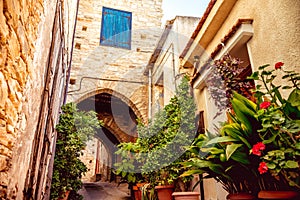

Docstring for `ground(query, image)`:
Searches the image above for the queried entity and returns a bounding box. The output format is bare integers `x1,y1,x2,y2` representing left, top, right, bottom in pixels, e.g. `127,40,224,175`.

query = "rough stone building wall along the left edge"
0,0,76,199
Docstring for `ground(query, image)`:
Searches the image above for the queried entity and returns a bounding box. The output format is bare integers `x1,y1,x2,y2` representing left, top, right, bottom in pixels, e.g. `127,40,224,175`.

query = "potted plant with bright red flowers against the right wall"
246,62,300,199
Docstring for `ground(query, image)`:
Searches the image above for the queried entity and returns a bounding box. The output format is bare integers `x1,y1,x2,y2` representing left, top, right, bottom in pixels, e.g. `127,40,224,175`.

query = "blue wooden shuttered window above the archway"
100,7,132,49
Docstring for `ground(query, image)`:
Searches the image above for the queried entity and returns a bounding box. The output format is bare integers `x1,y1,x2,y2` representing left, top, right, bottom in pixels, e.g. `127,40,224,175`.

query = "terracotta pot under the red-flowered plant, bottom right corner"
258,190,300,200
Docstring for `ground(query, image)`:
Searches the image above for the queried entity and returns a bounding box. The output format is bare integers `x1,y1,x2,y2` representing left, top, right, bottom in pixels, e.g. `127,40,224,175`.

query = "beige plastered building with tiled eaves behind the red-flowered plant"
180,0,300,199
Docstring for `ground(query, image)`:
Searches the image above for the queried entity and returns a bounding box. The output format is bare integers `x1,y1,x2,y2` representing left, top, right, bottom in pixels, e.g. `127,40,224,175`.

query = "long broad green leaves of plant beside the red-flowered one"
182,92,260,193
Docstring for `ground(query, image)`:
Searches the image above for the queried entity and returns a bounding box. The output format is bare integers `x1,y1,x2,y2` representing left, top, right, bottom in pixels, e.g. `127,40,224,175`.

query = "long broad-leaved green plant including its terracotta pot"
182,96,259,199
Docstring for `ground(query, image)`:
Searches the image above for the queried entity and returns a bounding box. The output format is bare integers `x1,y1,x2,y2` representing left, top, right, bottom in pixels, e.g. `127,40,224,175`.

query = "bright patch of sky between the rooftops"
162,0,210,24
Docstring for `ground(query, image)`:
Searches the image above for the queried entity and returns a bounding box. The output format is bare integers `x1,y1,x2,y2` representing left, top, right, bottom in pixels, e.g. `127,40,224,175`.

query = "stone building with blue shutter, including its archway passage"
68,0,162,181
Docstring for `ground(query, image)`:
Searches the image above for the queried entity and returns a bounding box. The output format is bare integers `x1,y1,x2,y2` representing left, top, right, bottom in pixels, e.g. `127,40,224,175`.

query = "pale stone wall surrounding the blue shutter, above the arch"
68,0,162,120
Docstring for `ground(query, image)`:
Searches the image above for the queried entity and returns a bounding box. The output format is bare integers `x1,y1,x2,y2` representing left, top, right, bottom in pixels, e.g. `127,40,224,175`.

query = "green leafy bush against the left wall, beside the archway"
50,103,100,199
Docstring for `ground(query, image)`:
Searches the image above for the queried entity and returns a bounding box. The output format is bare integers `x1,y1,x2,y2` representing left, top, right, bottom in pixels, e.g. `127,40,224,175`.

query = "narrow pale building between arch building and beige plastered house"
144,16,199,118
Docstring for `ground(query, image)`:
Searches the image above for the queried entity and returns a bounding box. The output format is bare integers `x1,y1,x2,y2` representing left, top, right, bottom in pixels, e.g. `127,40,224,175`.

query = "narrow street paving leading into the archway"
79,182,130,200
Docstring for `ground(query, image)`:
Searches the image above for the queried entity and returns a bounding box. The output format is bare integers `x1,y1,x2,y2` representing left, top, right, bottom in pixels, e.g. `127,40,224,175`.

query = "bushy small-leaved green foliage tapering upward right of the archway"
116,77,196,191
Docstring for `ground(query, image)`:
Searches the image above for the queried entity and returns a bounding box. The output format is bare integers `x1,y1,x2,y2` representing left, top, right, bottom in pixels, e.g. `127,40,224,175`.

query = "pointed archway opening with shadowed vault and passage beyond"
77,91,137,181
